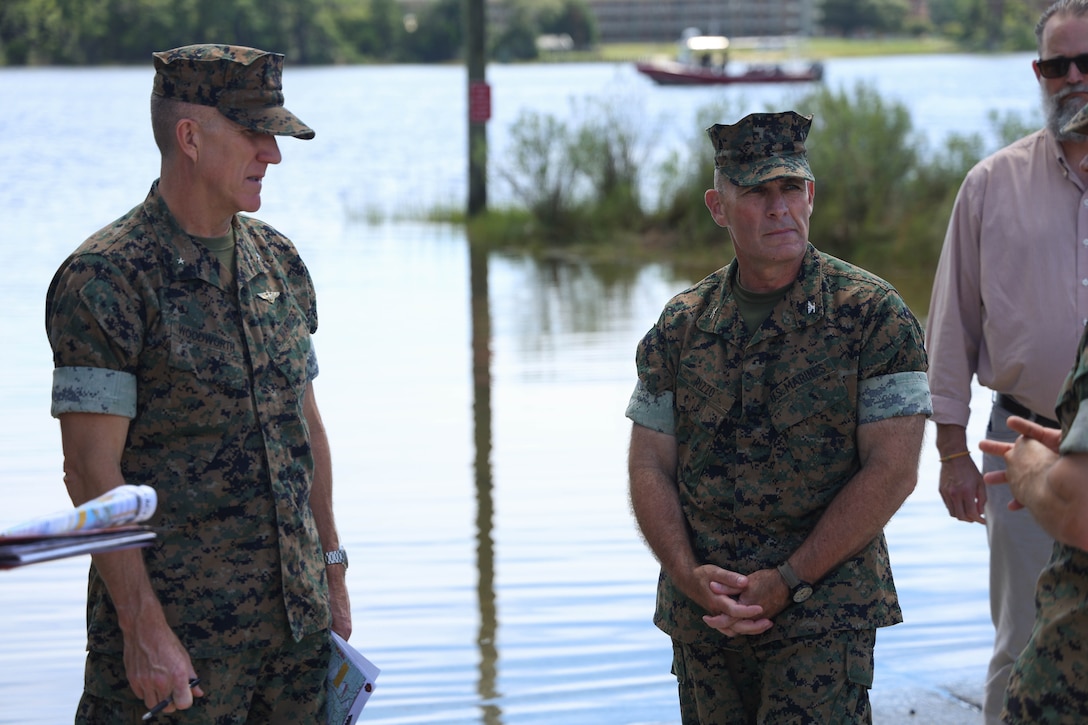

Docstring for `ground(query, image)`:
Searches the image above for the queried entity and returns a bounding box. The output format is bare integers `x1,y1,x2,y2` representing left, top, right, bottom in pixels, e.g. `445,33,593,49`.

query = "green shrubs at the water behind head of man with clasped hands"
486,84,1037,279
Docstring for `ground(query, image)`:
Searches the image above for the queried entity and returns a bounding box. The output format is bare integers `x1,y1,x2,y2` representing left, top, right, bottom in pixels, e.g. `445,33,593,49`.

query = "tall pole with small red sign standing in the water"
465,0,491,217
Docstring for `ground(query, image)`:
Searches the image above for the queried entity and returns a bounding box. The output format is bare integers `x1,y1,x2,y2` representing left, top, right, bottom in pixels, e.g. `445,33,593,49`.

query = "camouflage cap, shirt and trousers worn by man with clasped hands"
627,108,930,725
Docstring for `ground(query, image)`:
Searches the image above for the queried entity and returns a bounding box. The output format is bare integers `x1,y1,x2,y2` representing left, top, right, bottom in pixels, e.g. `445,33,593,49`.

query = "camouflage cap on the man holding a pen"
151,45,314,138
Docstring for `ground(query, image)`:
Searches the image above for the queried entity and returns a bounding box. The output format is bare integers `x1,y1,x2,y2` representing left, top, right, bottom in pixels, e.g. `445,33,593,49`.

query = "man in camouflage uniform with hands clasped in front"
627,111,930,725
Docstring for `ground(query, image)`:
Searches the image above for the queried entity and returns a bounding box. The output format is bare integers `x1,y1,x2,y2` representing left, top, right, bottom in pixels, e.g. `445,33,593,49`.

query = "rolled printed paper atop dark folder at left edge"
0,484,158,569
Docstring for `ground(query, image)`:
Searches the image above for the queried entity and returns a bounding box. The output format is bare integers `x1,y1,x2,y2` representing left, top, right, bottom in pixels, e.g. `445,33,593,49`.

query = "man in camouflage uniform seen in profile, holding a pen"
46,45,351,725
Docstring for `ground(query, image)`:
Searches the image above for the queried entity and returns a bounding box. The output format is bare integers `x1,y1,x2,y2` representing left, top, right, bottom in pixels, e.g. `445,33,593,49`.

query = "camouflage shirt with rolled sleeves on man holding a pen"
46,180,329,658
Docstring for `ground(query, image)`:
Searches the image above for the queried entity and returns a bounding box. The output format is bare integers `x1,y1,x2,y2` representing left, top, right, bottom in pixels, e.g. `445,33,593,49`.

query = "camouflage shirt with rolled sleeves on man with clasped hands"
628,239,930,714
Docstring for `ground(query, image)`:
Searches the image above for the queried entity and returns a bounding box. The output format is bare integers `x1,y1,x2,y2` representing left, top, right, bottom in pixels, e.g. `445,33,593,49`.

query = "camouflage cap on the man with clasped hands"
706,111,816,186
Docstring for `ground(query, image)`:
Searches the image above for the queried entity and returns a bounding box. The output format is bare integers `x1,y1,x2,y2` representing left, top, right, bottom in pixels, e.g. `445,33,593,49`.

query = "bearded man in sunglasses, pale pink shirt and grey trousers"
926,0,1088,725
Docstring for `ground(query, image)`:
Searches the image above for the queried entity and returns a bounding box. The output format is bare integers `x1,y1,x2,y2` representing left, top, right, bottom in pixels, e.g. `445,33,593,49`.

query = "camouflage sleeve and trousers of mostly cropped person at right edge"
1004,322,1088,725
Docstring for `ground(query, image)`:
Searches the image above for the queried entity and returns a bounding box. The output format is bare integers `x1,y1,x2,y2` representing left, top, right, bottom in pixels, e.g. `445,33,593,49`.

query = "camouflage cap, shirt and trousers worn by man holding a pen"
46,46,343,723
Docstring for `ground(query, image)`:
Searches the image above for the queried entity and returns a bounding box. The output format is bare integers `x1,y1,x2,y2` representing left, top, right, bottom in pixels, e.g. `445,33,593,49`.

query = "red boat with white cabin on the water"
635,30,824,86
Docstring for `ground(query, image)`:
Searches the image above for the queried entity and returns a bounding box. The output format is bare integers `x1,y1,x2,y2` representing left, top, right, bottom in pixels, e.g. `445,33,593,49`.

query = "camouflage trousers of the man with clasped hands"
672,629,876,725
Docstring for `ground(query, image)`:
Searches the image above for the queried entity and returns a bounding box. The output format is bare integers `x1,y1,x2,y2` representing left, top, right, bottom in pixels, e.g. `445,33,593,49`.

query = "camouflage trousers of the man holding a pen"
75,631,331,725
